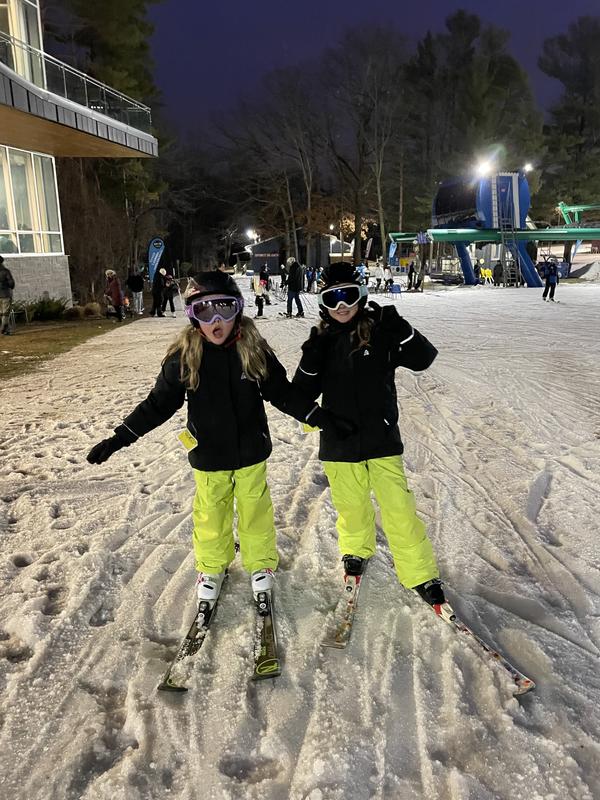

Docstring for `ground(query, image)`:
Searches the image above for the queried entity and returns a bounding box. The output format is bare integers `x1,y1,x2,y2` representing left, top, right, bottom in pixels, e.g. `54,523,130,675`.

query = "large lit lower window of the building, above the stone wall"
0,146,64,255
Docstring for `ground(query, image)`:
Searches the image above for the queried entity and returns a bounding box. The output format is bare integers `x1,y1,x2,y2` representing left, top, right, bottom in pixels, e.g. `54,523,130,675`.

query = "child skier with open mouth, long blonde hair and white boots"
87,270,351,602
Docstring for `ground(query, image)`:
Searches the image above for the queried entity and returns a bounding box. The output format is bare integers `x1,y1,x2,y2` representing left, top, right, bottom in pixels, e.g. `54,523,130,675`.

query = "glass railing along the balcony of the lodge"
0,31,152,133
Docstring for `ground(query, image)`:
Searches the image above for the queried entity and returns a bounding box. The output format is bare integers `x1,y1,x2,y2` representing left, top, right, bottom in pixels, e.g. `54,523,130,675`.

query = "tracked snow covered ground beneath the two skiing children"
0,283,600,800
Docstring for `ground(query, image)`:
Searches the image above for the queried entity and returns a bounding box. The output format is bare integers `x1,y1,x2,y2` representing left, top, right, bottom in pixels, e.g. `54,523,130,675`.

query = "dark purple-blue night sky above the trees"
151,0,600,132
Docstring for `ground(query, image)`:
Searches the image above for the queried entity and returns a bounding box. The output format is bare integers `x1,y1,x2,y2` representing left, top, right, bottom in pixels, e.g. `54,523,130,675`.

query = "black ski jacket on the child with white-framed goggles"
293,304,437,462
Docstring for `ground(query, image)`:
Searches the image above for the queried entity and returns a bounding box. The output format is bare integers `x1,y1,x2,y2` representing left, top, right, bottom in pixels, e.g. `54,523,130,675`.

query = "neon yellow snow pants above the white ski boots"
193,461,279,573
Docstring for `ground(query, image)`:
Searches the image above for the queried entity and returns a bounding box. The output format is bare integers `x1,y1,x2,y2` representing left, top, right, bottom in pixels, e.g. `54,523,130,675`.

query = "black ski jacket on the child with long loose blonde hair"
118,342,314,472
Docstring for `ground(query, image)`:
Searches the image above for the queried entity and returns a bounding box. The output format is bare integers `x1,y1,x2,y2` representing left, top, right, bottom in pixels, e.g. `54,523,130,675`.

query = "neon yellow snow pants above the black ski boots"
323,456,439,589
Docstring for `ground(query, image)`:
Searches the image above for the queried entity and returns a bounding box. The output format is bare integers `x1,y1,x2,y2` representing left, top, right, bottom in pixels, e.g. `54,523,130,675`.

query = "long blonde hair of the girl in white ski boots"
163,316,273,390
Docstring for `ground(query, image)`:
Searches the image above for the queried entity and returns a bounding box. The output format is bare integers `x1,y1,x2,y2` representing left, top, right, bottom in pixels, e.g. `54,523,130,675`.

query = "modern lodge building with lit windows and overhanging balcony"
0,0,158,305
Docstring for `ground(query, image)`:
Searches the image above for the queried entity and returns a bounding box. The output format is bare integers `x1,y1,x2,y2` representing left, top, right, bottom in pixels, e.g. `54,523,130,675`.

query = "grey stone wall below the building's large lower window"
4,254,73,306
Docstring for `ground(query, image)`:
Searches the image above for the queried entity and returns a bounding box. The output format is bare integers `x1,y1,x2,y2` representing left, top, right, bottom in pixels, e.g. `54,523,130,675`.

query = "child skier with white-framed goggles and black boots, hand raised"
293,263,445,606
